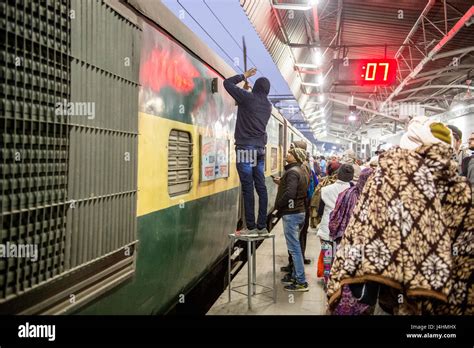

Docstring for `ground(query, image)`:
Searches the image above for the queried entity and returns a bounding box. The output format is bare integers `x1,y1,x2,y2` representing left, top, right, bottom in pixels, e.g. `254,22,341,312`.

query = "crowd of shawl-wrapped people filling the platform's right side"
310,117,474,315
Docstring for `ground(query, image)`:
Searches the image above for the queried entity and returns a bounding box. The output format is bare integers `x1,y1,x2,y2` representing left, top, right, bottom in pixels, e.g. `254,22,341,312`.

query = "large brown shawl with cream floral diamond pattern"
328,144,474,314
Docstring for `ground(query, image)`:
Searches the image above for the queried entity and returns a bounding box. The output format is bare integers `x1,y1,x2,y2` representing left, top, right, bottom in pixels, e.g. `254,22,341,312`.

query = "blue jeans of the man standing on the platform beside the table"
282,213,306,284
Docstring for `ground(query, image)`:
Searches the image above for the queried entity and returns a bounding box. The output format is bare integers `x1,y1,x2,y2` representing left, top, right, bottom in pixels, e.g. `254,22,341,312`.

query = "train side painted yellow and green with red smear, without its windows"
81,19,281,314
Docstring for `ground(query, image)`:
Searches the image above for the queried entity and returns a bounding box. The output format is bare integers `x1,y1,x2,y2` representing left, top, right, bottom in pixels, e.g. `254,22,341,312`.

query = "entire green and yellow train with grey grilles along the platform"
0,0,311,314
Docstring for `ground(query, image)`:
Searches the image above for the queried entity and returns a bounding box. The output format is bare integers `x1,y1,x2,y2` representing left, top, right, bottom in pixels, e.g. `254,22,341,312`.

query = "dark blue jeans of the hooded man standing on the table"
235,145,268,229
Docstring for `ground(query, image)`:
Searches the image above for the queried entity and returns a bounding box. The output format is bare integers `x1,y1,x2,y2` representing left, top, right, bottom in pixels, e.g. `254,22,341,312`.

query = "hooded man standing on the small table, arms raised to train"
224,69,272,235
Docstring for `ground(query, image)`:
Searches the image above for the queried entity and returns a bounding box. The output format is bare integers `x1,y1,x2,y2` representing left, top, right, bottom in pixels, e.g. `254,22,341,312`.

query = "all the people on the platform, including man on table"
224,69,474,315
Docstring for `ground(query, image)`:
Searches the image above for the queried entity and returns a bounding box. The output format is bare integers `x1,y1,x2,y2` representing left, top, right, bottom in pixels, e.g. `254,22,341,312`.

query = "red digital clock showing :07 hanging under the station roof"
334,59,397,86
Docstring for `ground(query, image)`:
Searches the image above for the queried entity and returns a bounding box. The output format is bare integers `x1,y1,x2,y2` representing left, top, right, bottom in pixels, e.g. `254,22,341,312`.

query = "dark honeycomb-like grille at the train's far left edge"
0,0,70,304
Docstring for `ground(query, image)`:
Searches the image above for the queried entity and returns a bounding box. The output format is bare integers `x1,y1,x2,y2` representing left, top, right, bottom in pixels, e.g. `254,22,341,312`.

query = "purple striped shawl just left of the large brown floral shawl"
329,168,374,242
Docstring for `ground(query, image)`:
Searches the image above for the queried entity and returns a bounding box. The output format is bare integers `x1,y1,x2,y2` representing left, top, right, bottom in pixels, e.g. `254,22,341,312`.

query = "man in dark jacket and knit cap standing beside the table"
275,147,309,291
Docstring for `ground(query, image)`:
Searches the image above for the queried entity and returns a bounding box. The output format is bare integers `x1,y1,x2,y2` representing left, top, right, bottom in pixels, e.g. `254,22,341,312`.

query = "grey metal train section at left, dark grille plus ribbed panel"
0,0,140,315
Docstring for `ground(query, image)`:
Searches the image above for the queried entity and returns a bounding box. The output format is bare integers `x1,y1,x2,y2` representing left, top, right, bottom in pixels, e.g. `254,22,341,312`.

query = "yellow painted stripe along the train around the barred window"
137,112,282,216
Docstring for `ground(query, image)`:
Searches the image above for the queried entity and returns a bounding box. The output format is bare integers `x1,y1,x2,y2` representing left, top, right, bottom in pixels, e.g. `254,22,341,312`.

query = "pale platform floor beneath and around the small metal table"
207,220,327,315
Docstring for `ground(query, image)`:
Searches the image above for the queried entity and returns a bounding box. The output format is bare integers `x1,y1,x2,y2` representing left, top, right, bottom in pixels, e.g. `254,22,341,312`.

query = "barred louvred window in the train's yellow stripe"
168,129,193,197
